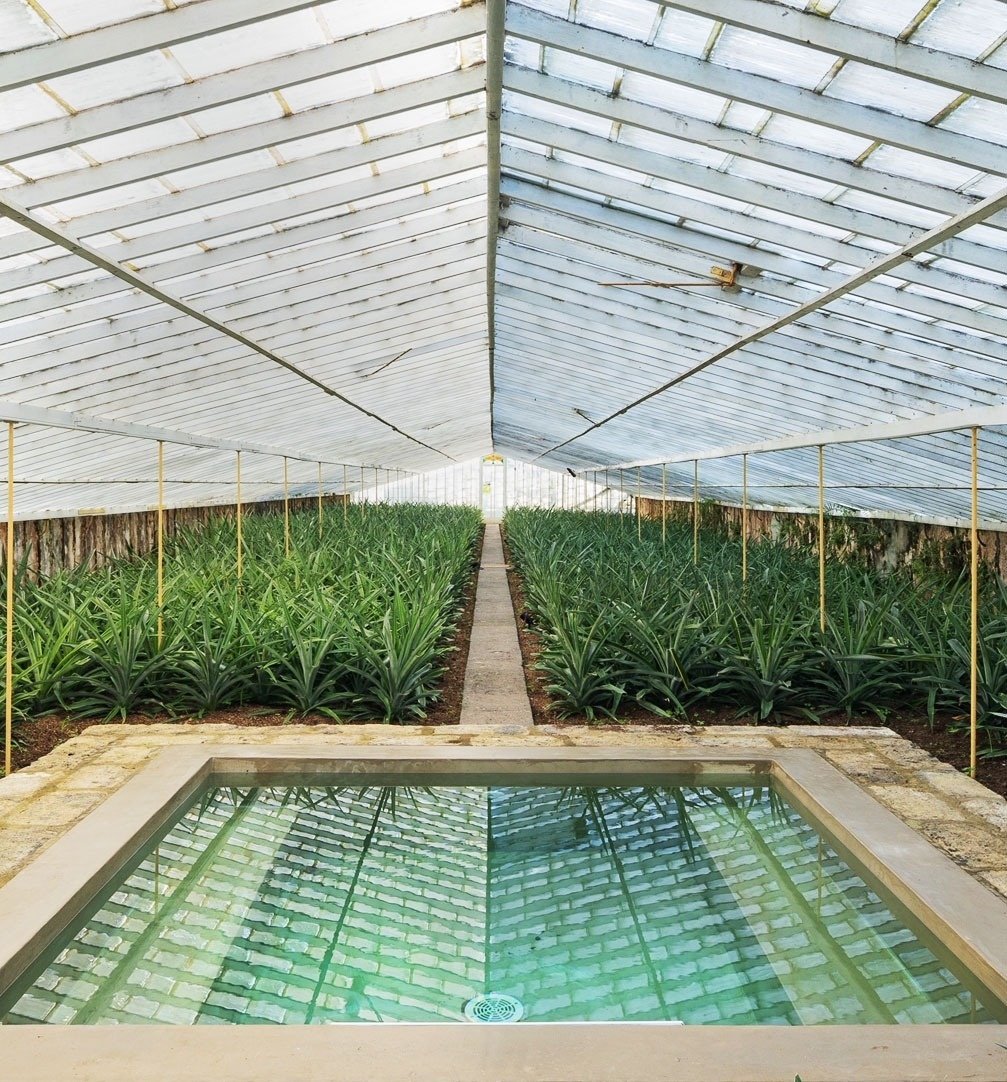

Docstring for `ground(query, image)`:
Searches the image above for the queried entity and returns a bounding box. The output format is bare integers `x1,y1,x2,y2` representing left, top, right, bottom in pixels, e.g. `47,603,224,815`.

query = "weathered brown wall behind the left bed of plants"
0,496,343,577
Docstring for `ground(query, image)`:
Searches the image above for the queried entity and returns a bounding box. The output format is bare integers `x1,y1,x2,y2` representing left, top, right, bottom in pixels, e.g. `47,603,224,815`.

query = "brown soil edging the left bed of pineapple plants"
0,525,482,775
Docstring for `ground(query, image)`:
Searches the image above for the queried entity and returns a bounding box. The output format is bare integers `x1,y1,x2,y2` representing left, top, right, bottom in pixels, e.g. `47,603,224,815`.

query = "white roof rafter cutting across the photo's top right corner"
650,0,1007,103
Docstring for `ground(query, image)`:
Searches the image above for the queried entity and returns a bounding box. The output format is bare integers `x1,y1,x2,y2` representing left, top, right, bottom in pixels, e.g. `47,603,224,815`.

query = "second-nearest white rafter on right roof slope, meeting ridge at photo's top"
507,2,1007,175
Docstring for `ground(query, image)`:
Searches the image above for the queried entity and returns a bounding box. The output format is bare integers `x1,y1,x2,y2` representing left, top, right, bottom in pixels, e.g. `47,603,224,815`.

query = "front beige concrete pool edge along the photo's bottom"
3,1022,1007,1082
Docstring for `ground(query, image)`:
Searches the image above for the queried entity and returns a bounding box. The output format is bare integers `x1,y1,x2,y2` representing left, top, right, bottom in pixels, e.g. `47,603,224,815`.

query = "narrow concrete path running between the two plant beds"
461,523,532,729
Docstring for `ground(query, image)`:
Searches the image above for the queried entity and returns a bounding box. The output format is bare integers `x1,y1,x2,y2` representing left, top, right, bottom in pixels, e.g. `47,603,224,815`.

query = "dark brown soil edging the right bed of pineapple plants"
504,536,1007,797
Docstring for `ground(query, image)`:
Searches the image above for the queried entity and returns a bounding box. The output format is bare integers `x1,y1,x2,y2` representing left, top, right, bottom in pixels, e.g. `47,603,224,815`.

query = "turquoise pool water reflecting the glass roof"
0,777,1007,1026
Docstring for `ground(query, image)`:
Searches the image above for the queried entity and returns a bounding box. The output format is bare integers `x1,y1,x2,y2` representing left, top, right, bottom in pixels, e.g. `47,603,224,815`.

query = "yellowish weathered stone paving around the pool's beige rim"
0,717,1007,897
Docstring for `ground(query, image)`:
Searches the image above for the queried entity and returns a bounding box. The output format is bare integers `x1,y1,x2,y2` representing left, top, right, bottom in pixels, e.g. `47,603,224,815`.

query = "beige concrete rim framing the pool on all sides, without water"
0,727,1007,1082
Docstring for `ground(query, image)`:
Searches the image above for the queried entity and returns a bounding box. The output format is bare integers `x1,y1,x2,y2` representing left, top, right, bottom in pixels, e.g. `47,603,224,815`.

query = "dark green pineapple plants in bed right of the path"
506,510,1007,755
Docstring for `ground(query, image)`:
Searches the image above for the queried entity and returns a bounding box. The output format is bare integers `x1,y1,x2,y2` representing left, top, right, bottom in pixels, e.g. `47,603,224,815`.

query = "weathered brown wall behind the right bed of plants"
640,498,1007,580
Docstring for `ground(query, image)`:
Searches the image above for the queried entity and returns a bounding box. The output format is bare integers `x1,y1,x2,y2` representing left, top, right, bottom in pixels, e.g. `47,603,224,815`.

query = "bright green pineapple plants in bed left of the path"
0,505,479,722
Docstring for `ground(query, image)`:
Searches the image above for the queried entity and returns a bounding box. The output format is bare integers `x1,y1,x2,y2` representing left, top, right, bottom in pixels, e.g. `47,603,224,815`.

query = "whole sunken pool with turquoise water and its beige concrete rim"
0,744,1007,1082
